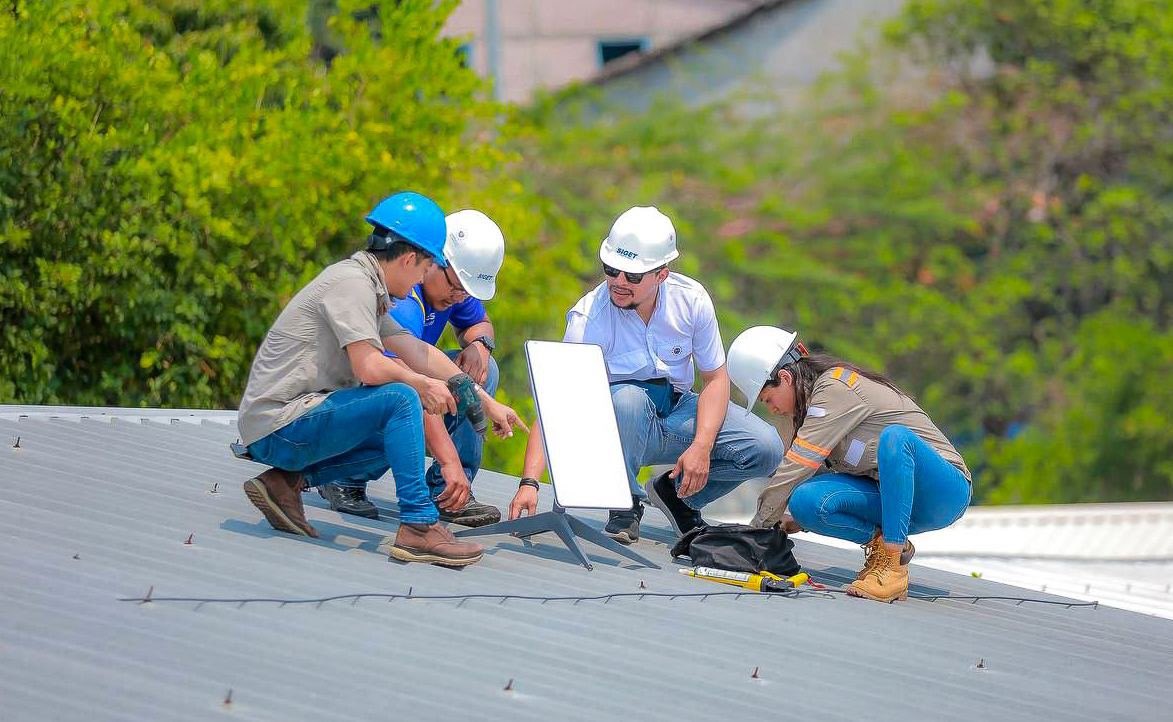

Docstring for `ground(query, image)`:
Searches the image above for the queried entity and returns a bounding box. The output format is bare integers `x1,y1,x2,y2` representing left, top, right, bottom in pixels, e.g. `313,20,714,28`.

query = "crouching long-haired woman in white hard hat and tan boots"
728,326,972,601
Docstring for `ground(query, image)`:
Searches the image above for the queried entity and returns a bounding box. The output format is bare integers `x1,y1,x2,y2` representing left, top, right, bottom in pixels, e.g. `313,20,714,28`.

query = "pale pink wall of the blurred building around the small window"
445,0,760,102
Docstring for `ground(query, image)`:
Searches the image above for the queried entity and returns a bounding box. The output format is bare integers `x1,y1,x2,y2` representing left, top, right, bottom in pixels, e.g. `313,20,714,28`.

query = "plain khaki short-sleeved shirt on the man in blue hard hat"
238,251,407,445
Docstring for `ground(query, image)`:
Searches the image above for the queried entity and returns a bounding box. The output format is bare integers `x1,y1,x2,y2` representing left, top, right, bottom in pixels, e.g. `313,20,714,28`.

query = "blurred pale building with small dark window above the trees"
445,0,903,102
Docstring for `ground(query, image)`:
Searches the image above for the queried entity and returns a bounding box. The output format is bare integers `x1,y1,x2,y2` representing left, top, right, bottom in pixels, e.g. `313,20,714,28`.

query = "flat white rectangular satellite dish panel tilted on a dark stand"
526,341,631,509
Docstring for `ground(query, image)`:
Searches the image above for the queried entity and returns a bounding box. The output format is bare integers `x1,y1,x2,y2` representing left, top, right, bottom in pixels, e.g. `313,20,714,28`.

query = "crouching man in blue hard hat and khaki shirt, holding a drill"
239,192,526,566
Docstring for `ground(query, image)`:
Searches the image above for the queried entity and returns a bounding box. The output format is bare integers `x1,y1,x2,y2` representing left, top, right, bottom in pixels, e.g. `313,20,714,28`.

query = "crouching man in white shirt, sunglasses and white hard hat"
509,206,784,544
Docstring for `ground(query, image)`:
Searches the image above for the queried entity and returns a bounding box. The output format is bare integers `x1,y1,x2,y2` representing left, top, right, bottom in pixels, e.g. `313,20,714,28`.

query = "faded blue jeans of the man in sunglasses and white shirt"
611,381,784,509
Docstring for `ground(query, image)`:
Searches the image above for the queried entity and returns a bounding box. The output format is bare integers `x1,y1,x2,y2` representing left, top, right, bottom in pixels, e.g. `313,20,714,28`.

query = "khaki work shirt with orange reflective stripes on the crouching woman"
751,367,972,526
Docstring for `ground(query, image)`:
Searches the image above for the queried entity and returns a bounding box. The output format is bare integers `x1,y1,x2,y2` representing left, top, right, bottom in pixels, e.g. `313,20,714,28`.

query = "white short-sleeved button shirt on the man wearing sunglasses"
562,273,725,391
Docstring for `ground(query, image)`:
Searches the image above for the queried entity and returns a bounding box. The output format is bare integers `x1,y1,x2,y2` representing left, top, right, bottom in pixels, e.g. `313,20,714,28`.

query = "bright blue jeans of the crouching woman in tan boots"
789,424,972,544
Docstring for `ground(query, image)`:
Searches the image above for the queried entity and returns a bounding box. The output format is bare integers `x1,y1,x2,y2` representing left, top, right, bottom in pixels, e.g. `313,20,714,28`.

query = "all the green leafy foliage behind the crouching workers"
0,0,1173,502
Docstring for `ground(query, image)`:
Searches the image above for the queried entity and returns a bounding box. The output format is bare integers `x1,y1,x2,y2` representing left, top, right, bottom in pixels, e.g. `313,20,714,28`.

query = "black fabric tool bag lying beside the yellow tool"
672,524,802,578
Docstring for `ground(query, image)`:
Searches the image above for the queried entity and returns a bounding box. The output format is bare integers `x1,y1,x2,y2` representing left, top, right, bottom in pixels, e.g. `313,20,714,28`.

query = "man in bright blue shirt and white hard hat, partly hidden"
318,210,504,526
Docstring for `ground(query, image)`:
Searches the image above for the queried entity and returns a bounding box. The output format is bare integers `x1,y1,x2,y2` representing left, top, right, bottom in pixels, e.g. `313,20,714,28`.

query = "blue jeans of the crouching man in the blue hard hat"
249,383,440,524
